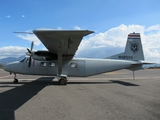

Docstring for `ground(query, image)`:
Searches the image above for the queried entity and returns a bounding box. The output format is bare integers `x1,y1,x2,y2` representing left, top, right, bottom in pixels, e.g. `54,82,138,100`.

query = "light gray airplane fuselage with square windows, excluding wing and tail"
4,57,142,77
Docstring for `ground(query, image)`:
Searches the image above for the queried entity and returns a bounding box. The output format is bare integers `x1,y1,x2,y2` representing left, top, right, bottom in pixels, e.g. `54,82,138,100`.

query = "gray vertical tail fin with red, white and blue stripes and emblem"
107,33,144,61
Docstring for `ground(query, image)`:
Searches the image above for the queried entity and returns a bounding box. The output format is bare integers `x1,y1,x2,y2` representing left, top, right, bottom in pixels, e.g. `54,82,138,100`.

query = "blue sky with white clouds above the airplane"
0,0,160,63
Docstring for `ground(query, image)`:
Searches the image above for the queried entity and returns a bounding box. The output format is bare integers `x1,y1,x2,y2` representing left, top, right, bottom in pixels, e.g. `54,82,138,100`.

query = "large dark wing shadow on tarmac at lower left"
0,77,54,120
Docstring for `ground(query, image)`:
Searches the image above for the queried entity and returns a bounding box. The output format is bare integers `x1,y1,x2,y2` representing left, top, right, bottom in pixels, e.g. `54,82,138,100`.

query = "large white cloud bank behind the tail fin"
75,24,160,62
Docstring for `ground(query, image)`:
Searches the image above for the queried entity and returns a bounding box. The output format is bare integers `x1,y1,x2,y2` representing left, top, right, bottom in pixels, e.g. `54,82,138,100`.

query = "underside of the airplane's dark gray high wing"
33,30,93,56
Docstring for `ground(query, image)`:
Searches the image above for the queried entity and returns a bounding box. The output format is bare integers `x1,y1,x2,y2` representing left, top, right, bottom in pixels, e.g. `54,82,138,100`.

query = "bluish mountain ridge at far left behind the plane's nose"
0,56,25,65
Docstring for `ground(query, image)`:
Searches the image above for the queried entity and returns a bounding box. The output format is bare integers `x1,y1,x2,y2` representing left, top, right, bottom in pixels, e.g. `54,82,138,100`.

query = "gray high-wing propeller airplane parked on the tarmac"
4,29,149,85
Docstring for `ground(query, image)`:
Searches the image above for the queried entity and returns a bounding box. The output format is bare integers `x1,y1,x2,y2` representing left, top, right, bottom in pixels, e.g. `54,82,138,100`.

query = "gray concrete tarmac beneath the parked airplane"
0,69,160,120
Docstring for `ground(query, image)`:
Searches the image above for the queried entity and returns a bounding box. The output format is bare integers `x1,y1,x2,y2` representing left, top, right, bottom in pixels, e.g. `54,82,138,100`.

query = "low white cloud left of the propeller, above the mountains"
0,46,27,59
